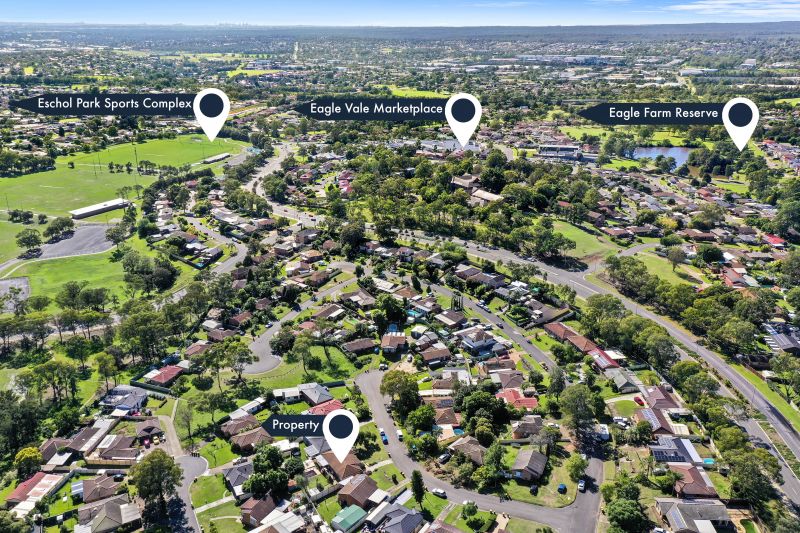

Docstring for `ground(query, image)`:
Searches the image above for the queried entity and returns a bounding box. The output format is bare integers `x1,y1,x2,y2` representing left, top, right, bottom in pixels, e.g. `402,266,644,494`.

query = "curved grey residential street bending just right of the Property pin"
356,370,603,533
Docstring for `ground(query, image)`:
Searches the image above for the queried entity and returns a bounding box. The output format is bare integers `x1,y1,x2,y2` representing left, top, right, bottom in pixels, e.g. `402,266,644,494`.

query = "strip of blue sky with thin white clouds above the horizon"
0,0,800,26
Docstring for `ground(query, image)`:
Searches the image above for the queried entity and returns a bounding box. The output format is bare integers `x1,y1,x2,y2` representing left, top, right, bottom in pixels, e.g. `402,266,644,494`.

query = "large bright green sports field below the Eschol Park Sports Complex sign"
0,135,247,215
